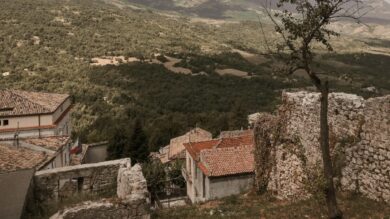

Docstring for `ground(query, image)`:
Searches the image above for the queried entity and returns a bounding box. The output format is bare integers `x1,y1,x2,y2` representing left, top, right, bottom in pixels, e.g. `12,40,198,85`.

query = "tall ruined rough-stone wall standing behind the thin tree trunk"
257,92,390,202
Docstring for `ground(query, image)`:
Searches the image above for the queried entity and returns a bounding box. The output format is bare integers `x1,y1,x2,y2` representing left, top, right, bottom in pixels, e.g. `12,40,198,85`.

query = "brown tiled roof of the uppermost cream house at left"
0,90,69,116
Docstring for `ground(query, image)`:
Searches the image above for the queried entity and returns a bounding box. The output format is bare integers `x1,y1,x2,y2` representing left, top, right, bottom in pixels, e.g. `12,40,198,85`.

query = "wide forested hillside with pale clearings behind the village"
0,0,390,150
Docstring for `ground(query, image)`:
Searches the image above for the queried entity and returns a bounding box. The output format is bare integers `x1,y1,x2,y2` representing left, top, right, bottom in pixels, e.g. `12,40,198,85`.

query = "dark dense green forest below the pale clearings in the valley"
80,63,292,150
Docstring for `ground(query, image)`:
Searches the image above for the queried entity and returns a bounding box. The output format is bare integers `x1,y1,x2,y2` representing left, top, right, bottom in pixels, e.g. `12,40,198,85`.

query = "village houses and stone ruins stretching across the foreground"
0,90,390,219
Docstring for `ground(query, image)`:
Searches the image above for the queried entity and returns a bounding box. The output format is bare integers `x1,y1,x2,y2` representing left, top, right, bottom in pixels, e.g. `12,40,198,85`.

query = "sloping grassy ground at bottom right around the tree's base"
152,194,390,219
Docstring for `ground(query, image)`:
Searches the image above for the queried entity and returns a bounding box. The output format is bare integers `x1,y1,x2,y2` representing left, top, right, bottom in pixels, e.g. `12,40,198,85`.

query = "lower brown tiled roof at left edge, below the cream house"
0,145,48,173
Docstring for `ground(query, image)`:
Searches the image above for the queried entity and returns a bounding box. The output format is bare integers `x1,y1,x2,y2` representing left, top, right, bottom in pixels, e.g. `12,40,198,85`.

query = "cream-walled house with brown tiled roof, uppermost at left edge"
0,90,72,139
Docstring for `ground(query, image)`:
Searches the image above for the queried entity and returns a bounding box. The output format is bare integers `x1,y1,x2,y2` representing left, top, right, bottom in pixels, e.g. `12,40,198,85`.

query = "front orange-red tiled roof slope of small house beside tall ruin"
198,146,255,176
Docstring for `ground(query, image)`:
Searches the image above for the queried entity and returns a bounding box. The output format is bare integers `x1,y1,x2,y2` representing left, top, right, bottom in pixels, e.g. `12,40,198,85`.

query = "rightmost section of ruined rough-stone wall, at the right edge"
341,96,390,202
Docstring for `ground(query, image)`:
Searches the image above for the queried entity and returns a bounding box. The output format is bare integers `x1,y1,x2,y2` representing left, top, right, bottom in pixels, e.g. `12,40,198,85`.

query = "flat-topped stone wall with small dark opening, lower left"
34,159,130,203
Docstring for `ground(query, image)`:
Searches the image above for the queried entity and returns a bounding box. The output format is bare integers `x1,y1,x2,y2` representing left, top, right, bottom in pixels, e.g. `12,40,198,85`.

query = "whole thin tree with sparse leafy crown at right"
261,0,368,218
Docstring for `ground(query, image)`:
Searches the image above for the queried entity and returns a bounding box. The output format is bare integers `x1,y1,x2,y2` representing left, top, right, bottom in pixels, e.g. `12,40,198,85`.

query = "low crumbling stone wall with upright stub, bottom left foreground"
51,164,150,219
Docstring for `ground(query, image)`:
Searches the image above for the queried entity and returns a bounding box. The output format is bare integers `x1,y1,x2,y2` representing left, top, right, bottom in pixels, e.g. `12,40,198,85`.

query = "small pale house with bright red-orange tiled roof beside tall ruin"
182,134,254,203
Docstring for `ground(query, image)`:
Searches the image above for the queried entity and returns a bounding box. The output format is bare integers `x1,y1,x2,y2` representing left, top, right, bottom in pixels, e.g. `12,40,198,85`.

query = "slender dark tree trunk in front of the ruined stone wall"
320,81,343,219
